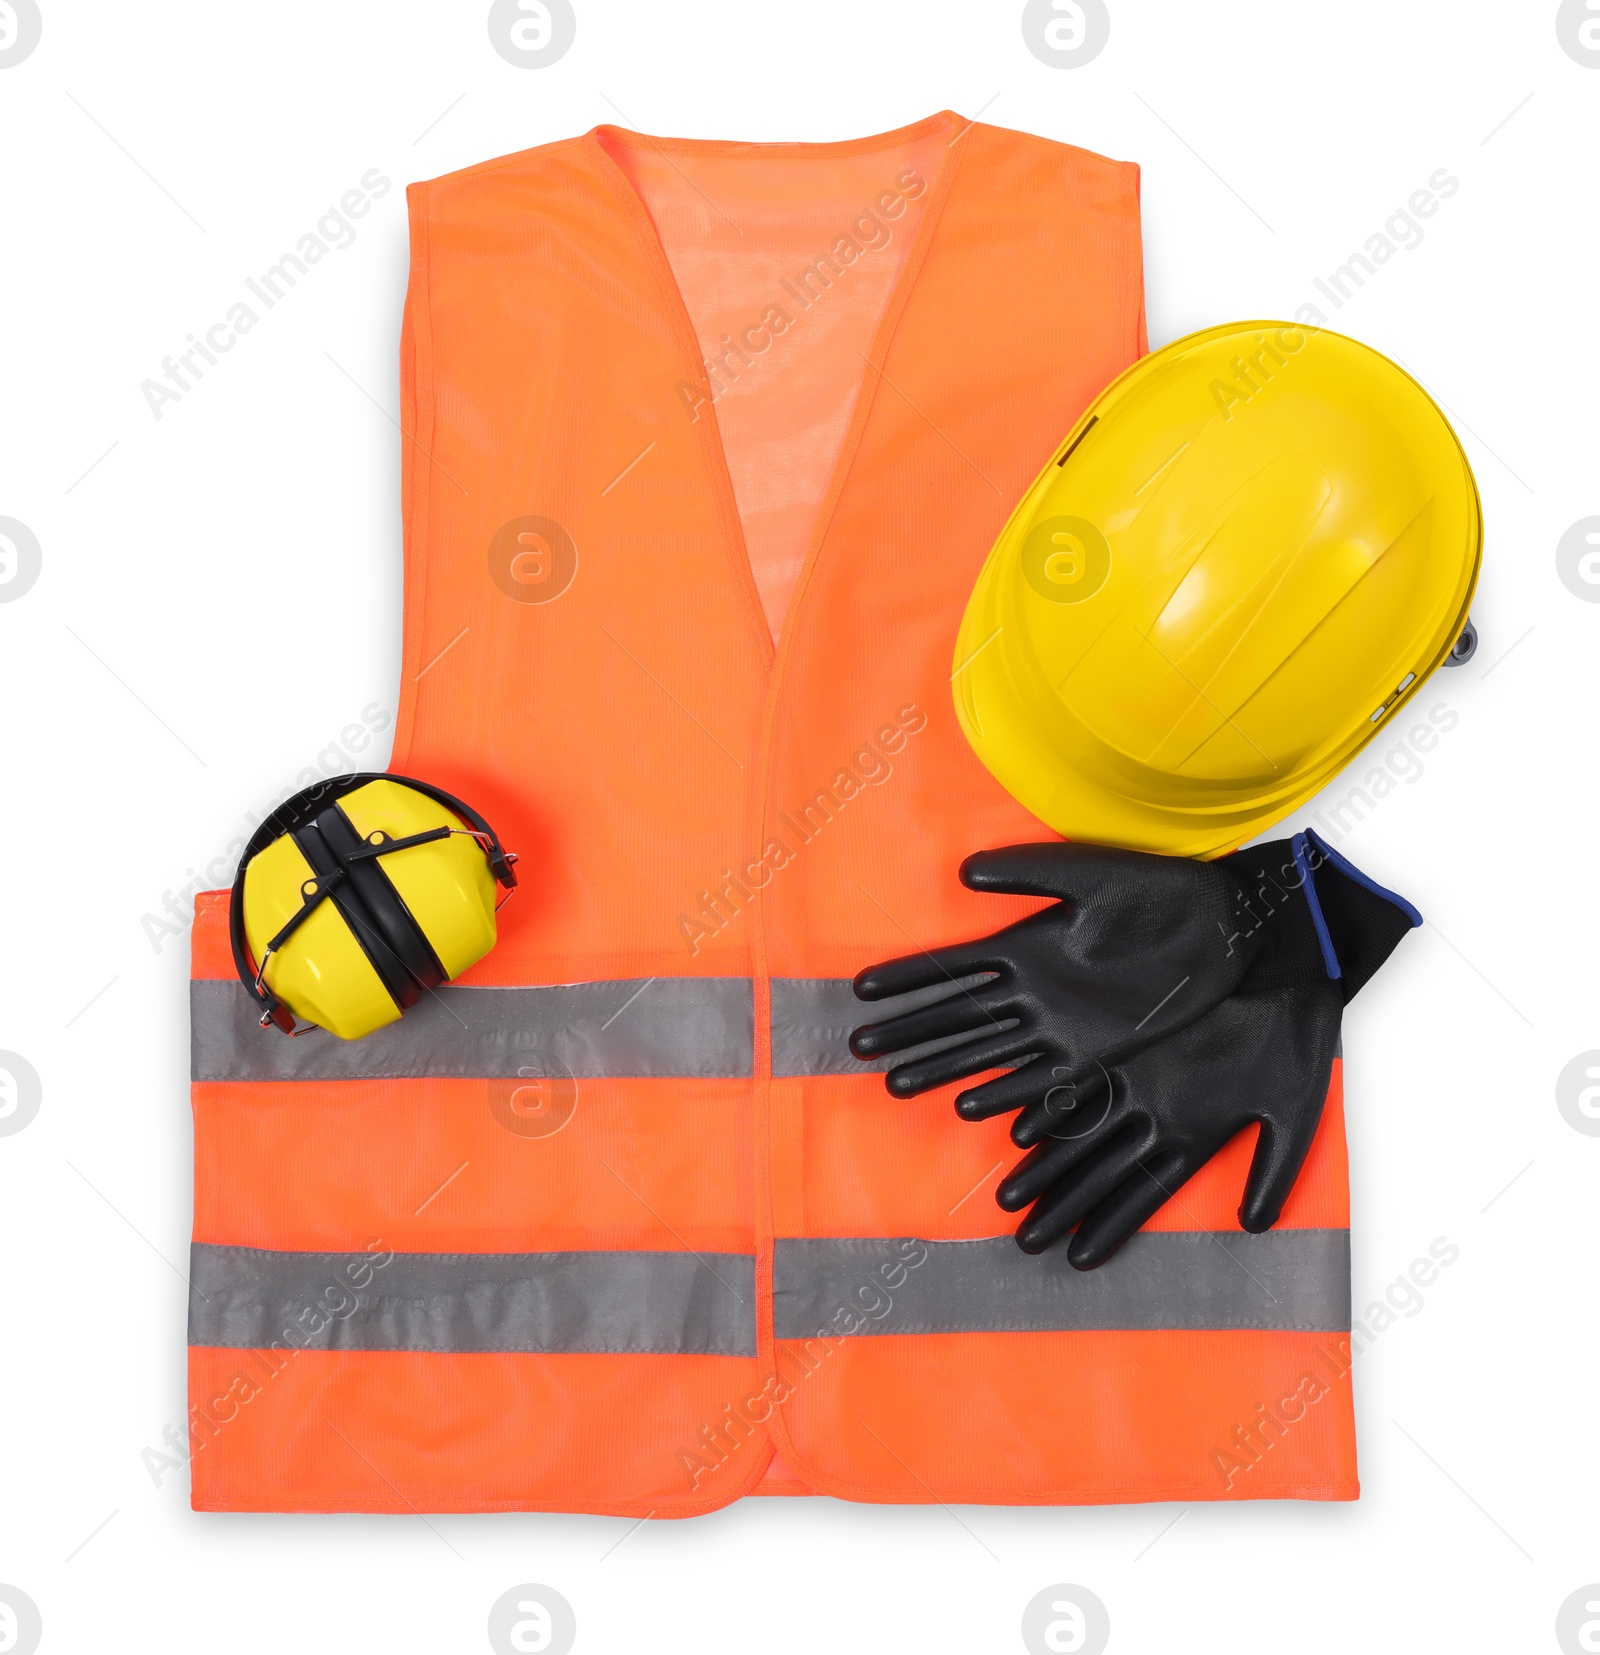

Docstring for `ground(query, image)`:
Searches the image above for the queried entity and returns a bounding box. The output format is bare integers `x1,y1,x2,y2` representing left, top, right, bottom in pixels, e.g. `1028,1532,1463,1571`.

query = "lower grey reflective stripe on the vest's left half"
189,1243,756,1355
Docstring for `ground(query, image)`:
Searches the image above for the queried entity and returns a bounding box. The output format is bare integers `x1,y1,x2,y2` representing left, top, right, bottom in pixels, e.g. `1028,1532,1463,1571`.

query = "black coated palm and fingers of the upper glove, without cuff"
850,841,1292,1120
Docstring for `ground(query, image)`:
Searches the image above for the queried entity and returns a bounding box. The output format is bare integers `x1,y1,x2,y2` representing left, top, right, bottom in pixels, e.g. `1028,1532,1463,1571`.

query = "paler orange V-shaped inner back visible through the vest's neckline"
599,118,955,639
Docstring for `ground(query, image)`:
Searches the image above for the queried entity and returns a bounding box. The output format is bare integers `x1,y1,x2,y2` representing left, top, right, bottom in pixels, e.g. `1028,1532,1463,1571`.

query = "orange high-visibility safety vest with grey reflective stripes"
190,114,1357,1518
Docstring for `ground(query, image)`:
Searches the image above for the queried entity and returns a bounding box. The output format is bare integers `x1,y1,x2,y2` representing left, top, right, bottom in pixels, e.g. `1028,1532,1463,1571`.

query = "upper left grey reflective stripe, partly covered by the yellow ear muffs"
189,976,754,1081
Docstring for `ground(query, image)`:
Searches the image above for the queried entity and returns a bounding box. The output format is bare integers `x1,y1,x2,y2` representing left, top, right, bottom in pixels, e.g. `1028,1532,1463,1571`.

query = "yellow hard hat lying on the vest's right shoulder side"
951,321,1483,857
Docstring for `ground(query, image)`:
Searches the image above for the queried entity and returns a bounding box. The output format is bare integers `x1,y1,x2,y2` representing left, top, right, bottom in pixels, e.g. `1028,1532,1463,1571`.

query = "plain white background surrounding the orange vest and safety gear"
0,0,1600,1652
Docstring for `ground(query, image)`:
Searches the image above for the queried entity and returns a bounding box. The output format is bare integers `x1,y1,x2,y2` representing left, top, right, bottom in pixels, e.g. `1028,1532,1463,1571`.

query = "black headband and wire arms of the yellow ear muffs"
228,771,516,1034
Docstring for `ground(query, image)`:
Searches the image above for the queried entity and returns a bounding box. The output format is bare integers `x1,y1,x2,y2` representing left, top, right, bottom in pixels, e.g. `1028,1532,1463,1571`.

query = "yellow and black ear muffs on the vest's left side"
228,773,516,1039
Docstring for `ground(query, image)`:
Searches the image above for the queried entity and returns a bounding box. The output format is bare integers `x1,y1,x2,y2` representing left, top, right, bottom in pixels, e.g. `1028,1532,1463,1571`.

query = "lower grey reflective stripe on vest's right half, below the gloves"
773,1230,1350,1339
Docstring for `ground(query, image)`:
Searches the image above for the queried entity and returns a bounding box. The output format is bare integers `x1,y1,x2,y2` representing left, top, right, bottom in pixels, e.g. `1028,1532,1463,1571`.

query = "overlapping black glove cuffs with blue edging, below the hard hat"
1224,829,1423,1005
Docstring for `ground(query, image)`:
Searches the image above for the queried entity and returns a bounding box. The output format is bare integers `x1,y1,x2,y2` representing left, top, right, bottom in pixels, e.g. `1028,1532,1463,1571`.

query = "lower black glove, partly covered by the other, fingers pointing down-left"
852,832,1421,1269
